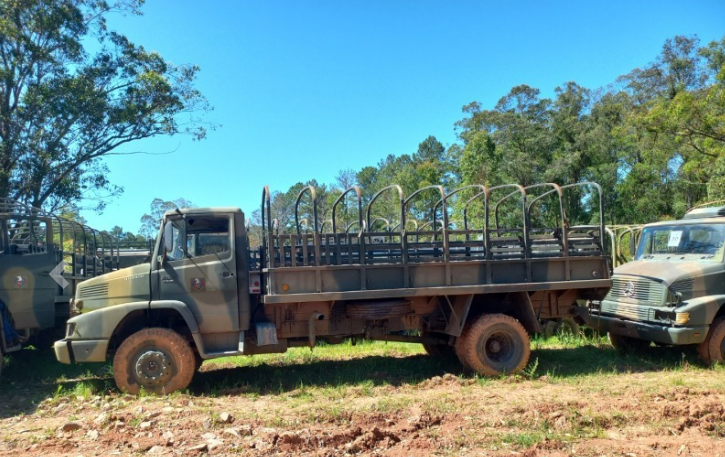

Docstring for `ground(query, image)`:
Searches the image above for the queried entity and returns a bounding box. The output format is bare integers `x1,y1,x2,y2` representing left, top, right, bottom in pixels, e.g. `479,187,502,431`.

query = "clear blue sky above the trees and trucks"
82,0,725,232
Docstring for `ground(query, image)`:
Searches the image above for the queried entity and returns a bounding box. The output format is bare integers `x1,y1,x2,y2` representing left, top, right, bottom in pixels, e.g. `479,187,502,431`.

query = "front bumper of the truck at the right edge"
586,314,710,345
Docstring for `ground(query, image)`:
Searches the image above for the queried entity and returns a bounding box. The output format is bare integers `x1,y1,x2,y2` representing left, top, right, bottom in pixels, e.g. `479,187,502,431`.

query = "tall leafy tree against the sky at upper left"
0,0,209,210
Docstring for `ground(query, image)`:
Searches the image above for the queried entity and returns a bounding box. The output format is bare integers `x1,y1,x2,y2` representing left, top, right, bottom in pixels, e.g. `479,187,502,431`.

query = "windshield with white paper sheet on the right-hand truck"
637,224,725,262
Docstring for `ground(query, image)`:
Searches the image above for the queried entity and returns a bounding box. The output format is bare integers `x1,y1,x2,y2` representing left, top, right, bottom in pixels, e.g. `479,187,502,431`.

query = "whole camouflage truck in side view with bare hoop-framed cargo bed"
55,183,611,393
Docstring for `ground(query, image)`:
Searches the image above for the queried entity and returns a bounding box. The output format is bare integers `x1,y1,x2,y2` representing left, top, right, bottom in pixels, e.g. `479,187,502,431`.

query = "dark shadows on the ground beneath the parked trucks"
0,343,701,417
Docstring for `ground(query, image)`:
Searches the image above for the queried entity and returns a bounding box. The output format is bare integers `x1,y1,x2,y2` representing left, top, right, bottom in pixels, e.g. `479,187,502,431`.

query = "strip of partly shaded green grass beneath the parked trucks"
0,330,725,415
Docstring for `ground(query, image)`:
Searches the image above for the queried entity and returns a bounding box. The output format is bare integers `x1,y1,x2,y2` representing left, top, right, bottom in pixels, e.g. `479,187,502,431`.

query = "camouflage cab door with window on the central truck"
157,214,239,333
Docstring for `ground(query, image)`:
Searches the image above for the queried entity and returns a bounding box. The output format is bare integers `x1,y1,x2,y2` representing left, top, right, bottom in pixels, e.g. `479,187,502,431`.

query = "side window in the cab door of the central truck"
186,216,232,259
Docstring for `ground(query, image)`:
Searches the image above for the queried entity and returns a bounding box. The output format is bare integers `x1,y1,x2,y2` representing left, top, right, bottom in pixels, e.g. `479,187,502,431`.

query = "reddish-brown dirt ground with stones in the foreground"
0,350,725,457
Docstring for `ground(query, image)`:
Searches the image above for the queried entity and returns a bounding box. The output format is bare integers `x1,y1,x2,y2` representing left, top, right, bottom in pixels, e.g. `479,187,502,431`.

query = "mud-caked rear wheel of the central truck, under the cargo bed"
461,314,531,376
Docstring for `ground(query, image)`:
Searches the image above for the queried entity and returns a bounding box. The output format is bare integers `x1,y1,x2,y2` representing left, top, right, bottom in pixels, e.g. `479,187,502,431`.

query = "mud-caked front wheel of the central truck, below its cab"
113,328,196,394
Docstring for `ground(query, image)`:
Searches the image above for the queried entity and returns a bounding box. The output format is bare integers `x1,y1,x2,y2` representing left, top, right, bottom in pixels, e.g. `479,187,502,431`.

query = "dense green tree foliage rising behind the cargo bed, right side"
255,36,725,233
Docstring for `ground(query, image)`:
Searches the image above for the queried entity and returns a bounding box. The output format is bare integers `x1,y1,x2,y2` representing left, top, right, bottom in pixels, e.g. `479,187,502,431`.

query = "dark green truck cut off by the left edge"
0,199,118,376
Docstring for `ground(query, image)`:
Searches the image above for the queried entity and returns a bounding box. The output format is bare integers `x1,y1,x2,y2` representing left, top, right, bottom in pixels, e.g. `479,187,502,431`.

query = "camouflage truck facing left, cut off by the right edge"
582,207,725,364
